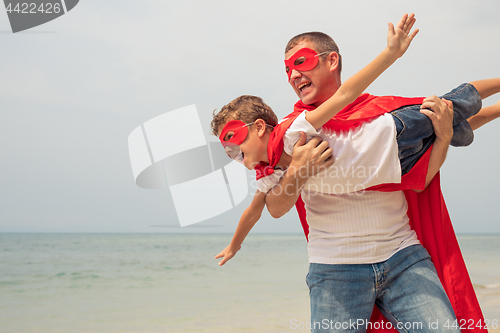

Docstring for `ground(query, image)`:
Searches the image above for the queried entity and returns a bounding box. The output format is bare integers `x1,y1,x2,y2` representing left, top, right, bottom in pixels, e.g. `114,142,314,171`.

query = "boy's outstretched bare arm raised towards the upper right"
306,14,418,128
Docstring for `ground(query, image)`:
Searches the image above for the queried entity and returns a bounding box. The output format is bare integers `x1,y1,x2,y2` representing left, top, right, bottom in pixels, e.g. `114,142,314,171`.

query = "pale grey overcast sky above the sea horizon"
0,0,500,233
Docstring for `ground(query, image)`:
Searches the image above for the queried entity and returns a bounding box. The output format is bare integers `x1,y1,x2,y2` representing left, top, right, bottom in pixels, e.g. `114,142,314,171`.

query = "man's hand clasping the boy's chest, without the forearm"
287,132,334,178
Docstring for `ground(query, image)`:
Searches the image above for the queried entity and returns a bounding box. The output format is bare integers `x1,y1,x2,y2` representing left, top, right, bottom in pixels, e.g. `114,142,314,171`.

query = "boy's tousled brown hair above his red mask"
210,95,278,136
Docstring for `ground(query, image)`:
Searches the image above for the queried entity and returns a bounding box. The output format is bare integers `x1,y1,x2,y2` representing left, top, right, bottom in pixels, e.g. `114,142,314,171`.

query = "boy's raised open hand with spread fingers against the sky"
387,13,418,58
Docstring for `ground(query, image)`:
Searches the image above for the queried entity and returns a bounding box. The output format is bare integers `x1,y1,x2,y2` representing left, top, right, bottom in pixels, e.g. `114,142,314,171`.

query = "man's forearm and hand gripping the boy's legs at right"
420,96,453,187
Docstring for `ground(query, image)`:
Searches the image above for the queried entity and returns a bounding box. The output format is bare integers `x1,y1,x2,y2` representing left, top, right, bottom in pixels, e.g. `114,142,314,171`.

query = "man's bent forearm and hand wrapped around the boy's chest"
266,132,334,218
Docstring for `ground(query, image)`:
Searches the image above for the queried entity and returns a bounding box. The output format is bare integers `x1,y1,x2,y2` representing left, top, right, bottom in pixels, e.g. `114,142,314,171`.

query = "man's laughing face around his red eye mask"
285,40,339,107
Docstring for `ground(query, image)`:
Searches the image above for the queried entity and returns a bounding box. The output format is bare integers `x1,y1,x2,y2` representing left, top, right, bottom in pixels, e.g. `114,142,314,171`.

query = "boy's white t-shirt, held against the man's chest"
257,111,401,194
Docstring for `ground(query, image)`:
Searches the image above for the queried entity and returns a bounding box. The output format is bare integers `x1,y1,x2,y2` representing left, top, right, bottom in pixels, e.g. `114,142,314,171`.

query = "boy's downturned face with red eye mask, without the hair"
218,119,269,170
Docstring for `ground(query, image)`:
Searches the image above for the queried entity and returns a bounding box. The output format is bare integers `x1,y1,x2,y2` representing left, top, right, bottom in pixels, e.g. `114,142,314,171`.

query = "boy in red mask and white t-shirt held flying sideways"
212,18,500,265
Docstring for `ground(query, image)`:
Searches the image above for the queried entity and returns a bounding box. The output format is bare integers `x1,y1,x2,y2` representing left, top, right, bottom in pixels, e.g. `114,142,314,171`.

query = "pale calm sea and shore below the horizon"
0,233,500,333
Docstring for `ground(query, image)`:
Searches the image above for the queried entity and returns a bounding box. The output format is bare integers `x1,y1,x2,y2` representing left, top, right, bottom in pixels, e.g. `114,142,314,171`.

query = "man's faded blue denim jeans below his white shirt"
306,245,460,333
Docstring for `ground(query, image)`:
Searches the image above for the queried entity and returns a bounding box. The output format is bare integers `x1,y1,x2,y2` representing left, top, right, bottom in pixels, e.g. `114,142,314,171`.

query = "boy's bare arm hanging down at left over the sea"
215,191,266,266
